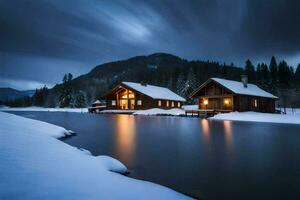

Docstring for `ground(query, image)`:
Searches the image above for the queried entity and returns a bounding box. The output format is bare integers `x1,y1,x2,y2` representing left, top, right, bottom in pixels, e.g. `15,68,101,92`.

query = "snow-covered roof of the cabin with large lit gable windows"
122,82,185,101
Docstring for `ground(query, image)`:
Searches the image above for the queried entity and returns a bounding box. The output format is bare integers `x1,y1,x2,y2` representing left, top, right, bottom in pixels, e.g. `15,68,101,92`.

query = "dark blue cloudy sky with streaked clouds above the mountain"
0,0,300,89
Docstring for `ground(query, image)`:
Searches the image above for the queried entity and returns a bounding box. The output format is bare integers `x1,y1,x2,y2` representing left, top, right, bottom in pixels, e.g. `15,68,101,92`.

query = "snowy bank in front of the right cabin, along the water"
210,112,300,124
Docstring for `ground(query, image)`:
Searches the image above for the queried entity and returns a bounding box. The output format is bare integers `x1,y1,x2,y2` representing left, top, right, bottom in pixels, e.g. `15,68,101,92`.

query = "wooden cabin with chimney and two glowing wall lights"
191,76,278,113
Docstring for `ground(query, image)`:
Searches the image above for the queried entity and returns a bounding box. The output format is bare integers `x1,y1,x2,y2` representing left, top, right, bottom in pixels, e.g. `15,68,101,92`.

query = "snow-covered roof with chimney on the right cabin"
211,78,278,98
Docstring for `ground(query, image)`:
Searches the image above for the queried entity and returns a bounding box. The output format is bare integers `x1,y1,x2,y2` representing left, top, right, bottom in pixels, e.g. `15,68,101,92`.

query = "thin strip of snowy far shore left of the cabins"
0,106,88,113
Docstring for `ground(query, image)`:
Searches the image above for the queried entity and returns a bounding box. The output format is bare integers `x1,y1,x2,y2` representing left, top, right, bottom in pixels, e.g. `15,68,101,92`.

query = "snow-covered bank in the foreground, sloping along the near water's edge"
0,112,188,200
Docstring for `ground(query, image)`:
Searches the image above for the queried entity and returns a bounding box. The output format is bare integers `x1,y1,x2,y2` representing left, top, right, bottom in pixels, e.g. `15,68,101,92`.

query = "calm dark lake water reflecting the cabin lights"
8,112,300,199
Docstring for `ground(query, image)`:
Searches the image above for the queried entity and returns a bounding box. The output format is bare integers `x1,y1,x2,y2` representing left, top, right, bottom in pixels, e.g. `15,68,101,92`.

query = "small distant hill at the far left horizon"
0,88,35,101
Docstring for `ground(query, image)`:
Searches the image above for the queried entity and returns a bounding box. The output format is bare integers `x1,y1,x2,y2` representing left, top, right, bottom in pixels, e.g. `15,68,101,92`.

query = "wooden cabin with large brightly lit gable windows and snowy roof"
102,82,185,110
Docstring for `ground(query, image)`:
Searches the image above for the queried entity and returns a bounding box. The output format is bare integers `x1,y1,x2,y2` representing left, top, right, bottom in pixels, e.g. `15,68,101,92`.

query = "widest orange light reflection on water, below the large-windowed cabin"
115,115,136,162
